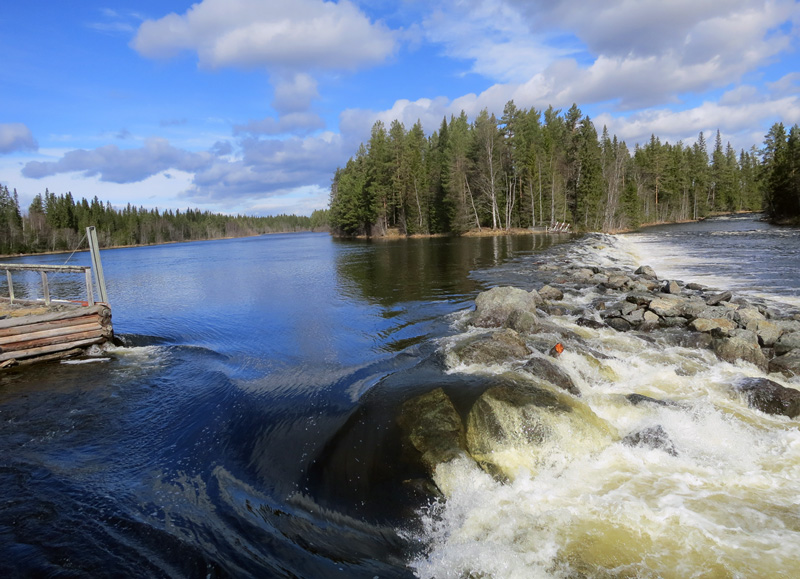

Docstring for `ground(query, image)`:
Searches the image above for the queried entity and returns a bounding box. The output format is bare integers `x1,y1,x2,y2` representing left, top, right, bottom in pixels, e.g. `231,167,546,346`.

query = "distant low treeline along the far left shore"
0,186,327,254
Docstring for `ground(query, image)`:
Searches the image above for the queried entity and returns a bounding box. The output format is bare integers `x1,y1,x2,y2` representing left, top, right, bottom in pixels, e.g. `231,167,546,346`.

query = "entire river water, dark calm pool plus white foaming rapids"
0,217,800,578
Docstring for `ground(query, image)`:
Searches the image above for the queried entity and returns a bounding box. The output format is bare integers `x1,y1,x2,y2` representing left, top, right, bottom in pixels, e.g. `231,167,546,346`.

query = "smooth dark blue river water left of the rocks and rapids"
0,234,564,578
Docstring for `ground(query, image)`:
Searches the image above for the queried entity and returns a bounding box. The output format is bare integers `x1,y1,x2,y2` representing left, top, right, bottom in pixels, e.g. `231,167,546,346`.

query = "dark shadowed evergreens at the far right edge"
762,123,800,222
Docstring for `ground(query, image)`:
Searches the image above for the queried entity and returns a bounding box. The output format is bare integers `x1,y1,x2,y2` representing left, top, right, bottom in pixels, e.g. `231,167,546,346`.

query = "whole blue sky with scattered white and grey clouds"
0,0,800,215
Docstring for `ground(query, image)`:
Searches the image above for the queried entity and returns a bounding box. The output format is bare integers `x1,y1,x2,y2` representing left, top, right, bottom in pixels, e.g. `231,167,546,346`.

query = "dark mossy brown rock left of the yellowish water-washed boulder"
397,388,467,473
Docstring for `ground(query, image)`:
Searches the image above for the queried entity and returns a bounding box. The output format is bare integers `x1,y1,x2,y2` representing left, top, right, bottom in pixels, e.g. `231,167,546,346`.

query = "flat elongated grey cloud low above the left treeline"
22,138,213,183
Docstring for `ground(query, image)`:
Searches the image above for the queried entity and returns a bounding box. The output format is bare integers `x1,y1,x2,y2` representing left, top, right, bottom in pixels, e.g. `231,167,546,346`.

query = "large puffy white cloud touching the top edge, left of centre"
132,0,396,70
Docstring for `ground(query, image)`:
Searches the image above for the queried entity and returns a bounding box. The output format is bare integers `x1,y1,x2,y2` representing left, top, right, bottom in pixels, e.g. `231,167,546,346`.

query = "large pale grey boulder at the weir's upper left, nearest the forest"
471,287,541,331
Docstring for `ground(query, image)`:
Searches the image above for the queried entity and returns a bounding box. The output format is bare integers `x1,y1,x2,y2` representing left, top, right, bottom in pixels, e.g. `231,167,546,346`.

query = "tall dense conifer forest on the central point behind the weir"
330,101,764,236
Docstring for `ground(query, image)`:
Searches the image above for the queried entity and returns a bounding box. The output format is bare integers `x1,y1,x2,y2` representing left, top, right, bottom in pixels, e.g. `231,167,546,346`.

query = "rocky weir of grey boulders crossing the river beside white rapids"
398,263,800,494
